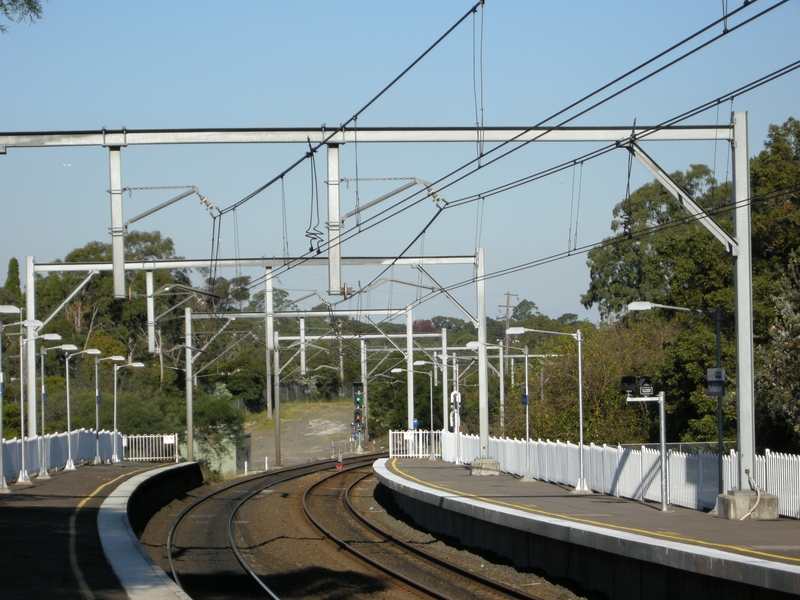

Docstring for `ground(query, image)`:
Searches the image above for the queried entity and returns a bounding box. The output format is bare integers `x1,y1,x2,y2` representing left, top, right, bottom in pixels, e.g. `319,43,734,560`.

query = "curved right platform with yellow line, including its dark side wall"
375,458,800,598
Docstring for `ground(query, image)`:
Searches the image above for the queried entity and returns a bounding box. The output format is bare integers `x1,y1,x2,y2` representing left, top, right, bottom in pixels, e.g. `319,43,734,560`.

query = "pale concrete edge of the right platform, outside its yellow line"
374,459,800,594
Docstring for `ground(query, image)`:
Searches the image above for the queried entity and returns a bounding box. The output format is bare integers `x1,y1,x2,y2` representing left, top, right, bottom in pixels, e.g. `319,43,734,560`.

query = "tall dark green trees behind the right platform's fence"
581,118,800,451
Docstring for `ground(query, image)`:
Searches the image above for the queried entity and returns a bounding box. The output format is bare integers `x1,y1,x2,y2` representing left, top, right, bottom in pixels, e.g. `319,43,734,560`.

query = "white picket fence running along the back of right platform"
389,431,800,519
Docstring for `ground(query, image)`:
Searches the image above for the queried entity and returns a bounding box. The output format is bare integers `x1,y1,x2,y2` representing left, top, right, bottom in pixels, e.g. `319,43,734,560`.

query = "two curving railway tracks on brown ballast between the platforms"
162,455,552,600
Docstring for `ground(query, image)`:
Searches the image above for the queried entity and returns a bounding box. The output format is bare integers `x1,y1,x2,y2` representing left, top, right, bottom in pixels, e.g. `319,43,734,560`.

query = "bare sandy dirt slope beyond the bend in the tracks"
245,402,368,470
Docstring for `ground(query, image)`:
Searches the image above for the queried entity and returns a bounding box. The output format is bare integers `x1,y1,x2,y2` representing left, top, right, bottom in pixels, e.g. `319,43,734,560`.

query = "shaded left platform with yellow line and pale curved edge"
0,462,191,599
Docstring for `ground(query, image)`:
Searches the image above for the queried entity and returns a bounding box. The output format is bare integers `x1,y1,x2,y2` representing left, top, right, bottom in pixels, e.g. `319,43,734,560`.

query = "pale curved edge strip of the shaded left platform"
97,463,195,600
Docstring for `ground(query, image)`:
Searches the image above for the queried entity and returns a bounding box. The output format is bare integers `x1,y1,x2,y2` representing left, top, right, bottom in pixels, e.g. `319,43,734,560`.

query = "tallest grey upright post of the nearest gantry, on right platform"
733,112,756,489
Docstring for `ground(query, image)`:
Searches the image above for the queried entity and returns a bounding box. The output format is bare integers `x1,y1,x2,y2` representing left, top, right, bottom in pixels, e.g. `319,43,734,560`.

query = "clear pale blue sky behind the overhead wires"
0,0,800,322
